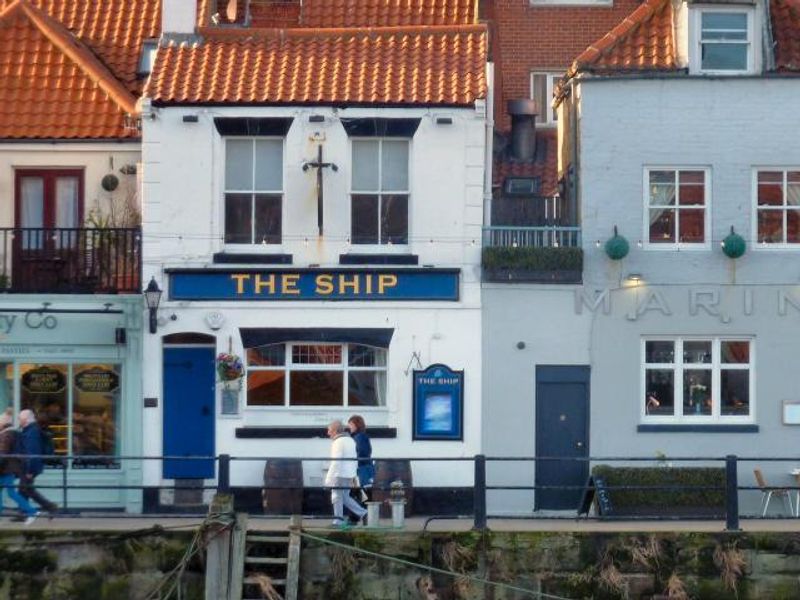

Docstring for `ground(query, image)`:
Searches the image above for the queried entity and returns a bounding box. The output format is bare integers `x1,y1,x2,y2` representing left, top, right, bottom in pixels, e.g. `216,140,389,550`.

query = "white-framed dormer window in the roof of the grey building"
693,8,754,74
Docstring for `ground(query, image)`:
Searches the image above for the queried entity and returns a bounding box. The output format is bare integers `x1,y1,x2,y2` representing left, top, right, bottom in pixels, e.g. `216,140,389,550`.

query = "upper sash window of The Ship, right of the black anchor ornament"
350,138,409,244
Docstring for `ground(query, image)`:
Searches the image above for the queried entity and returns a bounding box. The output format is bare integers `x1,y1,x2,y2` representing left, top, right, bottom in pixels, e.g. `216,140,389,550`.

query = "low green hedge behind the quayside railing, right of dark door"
592,465,725,514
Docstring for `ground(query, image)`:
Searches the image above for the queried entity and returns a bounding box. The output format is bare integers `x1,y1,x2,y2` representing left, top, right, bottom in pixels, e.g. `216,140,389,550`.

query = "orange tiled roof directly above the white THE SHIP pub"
145,25,487,105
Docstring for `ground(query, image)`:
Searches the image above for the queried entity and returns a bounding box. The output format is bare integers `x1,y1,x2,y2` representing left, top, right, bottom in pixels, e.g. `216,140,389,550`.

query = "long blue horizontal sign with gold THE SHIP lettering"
169,268,459,302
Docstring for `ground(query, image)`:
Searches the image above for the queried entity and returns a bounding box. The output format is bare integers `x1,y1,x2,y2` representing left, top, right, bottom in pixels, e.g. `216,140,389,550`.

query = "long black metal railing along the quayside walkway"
6,454,800,531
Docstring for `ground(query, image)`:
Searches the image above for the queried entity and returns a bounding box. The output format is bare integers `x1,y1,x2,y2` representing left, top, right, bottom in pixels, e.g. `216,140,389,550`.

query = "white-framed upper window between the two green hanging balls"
645,168,709,247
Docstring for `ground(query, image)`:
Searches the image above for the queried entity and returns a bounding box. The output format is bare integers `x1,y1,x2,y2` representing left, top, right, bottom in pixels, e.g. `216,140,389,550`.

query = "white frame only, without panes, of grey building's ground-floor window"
638,335,756,425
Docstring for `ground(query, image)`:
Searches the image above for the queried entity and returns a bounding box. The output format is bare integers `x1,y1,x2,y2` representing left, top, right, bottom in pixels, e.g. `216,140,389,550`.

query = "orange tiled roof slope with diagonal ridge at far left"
0,0,147,139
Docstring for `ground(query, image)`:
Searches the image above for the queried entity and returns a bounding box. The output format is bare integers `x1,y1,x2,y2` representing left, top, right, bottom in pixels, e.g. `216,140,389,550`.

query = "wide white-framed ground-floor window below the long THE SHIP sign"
247,342,387,408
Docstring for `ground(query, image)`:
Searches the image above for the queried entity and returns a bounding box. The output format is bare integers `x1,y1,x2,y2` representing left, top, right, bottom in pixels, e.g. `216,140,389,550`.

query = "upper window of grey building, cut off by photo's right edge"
756,169,800,244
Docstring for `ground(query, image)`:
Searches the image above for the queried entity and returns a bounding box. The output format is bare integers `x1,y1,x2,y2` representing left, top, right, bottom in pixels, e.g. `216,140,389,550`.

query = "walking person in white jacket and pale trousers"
325,421,367,527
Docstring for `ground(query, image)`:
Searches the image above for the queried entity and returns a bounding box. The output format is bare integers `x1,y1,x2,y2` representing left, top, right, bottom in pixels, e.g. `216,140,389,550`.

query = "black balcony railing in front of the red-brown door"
0,227,142,294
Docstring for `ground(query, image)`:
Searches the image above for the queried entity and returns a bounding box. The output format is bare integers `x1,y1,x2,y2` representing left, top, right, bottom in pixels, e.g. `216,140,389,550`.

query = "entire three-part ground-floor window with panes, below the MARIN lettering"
641,336,755,423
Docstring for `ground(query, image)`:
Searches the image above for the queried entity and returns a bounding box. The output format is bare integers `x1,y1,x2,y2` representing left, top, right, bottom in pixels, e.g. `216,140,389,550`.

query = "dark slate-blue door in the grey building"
535,366,589,510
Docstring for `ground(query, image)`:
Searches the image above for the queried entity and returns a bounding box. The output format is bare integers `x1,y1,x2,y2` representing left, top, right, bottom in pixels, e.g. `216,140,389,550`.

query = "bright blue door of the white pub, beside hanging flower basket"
163,346,215,479
